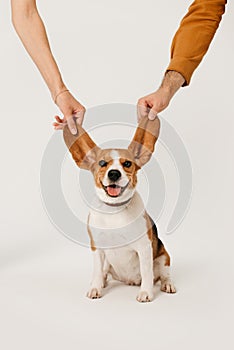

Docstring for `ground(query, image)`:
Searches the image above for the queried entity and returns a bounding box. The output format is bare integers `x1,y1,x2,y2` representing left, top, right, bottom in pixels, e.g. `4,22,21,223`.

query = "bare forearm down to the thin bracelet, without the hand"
11,0,65,99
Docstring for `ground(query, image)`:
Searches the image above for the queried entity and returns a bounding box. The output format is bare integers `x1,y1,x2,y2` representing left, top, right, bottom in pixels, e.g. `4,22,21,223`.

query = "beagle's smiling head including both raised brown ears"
63,117,160,204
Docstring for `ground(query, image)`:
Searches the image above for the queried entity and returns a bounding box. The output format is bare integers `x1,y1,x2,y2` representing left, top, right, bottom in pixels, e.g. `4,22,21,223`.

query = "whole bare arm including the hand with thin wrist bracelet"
11,0,85,134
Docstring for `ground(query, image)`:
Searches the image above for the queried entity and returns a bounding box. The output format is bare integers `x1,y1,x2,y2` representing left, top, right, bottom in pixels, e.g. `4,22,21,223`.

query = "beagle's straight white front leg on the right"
137,237,154,302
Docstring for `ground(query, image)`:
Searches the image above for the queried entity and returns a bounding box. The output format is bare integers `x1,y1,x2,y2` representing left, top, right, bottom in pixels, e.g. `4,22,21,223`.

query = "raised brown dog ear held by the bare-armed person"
63,125,100,170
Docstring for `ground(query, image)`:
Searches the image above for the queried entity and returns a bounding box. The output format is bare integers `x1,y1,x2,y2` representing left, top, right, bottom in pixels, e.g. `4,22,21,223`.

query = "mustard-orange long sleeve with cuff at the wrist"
167,0,227,86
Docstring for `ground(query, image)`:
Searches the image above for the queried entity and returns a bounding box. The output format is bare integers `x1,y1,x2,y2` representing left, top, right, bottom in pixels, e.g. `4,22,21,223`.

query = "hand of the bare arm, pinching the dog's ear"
53,91,85,135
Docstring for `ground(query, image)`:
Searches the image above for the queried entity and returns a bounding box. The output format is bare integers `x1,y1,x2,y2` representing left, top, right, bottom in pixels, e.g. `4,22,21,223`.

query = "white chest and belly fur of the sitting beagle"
89,192,148,284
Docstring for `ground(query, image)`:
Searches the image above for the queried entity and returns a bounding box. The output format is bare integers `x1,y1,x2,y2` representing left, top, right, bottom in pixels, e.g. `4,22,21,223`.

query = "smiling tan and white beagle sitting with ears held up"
63,117,176,302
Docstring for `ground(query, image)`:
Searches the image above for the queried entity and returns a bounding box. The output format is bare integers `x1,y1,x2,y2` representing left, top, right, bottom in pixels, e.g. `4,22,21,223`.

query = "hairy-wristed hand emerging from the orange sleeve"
137,71,185,122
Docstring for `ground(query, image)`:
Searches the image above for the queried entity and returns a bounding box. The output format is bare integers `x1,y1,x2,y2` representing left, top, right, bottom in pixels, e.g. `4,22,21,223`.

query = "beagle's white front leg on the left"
87,249,104,299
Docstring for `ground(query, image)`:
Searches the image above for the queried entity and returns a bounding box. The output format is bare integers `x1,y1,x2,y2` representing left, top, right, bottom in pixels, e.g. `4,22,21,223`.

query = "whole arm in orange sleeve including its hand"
138,0,226,119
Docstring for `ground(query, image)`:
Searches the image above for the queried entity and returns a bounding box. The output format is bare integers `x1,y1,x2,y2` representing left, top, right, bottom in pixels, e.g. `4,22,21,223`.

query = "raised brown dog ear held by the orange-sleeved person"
128,117,160,168
